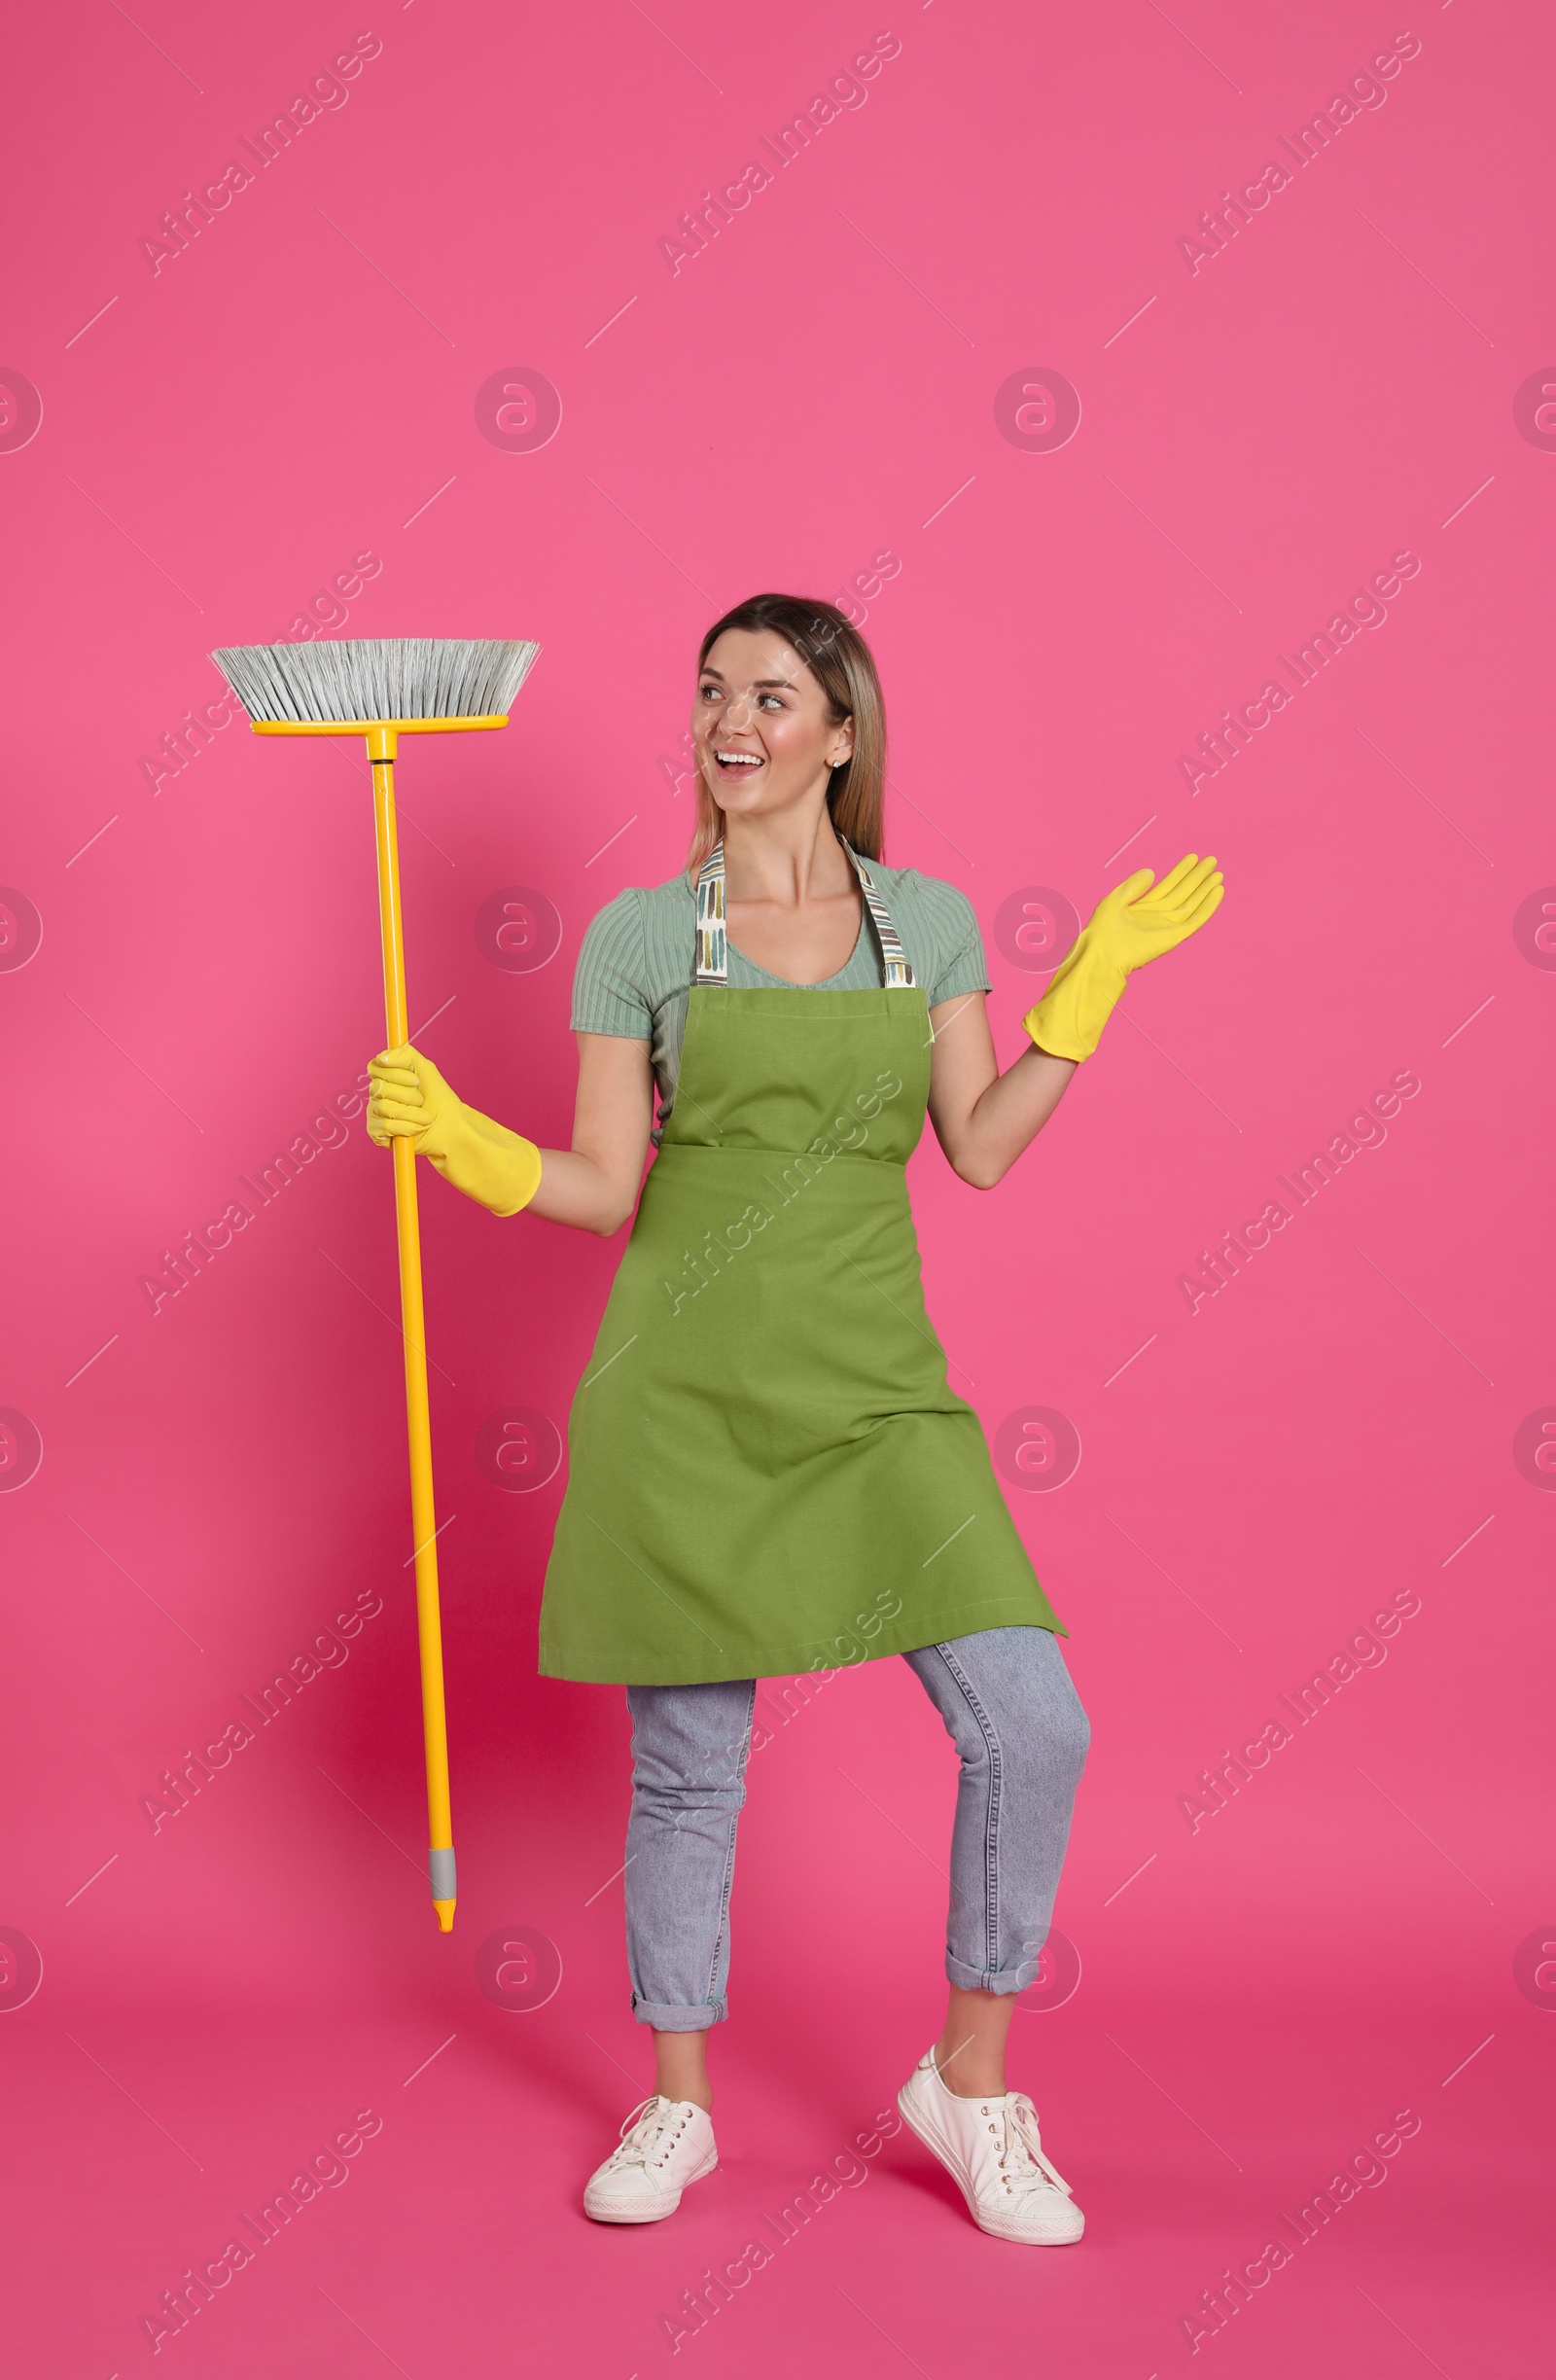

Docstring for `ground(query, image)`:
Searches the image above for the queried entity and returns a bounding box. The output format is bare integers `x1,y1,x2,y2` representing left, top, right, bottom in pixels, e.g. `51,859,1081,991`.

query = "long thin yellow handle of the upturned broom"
367,728,454,1933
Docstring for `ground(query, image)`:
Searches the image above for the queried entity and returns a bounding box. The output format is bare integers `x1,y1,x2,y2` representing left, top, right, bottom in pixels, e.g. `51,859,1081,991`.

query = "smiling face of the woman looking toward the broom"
692,628,854,816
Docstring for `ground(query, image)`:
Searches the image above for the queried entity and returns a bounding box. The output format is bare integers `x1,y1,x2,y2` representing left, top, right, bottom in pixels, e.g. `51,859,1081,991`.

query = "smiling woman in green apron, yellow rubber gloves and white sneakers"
369,595,1220,2245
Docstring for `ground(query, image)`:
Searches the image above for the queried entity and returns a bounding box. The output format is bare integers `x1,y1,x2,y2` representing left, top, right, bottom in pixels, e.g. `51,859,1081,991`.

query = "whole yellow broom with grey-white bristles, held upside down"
212,635,540,1933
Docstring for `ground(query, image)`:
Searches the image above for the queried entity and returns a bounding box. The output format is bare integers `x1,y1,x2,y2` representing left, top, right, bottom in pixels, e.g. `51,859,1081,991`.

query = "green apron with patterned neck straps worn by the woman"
540,845,1064,1685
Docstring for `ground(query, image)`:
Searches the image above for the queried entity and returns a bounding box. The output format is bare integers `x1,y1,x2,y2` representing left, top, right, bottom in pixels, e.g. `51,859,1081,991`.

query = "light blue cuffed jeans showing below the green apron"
623,1628,1092,2033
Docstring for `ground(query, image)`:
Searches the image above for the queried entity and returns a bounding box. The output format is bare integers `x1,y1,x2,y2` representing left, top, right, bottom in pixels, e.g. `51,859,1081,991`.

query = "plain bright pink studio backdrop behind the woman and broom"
0,0,1556,2380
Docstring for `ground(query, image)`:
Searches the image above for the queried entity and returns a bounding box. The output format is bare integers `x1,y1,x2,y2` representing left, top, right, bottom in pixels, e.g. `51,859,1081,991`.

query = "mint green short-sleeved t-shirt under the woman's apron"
571,859,990,1143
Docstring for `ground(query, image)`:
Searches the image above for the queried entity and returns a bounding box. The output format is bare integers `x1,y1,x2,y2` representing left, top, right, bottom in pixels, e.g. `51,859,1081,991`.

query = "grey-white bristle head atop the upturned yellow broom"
212,635,540,724
